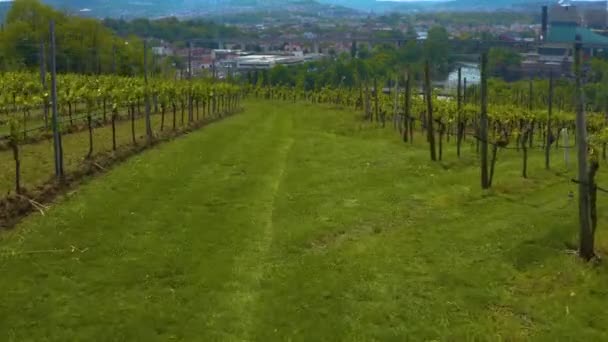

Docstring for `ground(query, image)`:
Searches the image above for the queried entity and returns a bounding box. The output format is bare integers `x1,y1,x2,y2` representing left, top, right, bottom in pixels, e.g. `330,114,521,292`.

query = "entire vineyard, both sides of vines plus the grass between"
0,47,608,340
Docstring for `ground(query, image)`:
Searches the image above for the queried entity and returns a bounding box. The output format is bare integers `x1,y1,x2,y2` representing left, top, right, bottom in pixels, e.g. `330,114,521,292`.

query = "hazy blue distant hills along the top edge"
0,0,554,18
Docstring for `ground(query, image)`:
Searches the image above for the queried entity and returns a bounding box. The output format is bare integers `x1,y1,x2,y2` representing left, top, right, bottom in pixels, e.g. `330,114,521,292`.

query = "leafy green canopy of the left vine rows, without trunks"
0,72,240,141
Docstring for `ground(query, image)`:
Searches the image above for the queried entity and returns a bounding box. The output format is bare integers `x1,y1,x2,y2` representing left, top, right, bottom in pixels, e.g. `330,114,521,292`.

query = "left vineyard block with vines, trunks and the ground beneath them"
0,73,242,227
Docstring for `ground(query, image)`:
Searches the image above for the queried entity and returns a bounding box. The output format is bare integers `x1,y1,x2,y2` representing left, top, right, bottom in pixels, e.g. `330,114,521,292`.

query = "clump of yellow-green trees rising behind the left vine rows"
0,0,150,75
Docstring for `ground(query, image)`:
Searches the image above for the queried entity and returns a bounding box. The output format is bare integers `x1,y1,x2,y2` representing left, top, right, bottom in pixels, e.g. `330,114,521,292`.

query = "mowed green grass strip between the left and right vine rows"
0,101,608,341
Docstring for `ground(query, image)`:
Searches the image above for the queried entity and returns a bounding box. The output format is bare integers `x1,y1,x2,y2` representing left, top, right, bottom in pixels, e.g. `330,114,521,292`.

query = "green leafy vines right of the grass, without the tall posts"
250,75,608,186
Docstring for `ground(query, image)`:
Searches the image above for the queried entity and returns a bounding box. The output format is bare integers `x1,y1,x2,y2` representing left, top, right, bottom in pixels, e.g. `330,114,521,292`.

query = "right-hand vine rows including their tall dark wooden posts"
248,50,608,260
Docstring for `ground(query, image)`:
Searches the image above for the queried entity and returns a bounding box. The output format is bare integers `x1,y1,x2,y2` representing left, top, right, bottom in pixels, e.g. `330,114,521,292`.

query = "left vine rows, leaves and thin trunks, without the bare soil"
0,73,241,195
